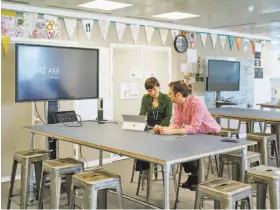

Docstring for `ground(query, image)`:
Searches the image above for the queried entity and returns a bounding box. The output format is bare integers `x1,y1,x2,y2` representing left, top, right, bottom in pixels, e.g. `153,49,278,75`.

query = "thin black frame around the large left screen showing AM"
15,43,100,103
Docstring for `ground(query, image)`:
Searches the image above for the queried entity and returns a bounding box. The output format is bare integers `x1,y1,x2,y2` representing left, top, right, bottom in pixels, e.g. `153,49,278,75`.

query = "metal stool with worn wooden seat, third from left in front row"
69,170,123,209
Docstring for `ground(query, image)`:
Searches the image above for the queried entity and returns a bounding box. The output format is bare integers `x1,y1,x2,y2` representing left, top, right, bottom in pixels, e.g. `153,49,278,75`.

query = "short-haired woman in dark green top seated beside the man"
136,77,173,171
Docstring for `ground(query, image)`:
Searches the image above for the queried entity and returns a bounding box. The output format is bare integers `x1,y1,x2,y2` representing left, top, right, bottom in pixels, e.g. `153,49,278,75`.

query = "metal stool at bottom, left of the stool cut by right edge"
194,178,253,209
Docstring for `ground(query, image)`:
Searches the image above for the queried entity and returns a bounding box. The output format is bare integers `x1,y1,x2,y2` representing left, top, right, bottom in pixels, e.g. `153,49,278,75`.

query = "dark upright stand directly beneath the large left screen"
47,101,58,159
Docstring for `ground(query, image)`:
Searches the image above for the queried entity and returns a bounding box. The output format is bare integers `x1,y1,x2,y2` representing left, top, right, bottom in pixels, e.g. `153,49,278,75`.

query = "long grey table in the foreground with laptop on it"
26,122,256,209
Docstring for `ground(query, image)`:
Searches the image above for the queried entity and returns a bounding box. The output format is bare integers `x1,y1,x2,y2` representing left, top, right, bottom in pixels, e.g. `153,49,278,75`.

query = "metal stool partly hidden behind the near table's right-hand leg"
219,151,261,181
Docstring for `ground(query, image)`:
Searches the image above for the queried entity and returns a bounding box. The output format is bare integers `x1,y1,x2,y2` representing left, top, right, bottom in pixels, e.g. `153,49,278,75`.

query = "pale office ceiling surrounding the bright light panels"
3,0,280,49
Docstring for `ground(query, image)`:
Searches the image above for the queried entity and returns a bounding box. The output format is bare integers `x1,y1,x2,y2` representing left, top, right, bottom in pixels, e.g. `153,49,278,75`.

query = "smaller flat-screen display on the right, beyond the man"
206,60,240,91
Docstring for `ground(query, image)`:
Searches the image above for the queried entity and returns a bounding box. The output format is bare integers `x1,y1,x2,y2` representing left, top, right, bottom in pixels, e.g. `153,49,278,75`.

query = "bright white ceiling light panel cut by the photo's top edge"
78,0,133,10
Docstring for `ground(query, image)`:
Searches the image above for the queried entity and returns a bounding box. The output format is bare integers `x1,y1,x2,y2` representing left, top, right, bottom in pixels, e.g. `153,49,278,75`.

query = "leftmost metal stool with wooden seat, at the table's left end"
7,149,49,209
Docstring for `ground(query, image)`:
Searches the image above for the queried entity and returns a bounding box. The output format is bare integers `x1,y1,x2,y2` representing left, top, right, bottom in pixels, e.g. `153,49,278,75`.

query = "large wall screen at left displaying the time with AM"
16,44,99,102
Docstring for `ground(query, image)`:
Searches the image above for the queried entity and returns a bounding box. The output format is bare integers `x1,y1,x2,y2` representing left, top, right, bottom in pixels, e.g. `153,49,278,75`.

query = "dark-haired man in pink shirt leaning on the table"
154,81,221,190
